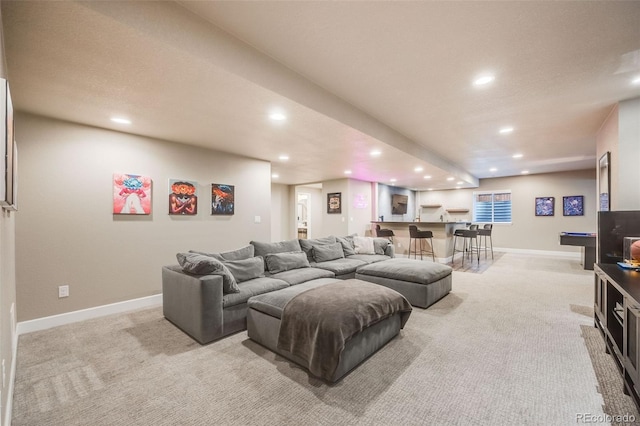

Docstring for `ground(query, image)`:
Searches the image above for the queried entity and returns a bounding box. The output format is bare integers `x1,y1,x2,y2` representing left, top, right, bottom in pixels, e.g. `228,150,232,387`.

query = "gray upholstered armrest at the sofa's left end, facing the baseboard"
162,265,224,344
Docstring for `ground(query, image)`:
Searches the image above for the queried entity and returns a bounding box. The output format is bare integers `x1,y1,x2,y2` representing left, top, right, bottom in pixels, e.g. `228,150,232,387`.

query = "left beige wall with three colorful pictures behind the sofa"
16,114,271,321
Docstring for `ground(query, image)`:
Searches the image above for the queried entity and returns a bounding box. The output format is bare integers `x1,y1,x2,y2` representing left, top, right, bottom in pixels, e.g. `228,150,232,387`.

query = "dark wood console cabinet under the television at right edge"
594,263,640,409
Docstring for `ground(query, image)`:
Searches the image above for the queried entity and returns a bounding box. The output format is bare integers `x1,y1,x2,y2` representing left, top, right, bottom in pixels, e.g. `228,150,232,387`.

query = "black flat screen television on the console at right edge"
598,210,640,263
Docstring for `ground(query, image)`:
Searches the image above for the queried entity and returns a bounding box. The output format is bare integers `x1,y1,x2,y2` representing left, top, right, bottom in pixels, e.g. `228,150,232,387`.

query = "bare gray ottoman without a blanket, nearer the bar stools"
356,258,452,308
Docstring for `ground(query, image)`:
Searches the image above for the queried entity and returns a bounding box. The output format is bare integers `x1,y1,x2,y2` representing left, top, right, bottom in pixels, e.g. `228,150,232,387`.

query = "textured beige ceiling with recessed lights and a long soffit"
2,1,640,189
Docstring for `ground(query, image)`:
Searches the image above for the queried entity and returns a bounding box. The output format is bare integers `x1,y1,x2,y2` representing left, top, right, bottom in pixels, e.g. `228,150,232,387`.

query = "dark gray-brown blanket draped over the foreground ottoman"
278,279,411,381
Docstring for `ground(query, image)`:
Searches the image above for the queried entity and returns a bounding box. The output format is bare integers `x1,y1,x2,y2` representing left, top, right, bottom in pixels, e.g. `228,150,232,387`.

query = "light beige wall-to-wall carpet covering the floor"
13,254,624,426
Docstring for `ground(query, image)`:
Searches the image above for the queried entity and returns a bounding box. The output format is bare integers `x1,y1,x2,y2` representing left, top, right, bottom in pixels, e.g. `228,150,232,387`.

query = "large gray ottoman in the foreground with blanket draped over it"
247,278,411,383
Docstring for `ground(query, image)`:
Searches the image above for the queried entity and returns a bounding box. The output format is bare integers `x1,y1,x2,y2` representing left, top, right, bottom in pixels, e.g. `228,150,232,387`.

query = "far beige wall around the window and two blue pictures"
419,165,597,252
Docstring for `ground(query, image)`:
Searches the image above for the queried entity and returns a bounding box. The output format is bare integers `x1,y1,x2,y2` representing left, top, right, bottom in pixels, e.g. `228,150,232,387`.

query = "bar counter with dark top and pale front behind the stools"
371,221,469,262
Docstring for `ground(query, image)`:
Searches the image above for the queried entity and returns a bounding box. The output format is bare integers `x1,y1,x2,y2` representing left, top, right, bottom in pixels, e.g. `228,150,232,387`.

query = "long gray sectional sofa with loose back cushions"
162,236,395,344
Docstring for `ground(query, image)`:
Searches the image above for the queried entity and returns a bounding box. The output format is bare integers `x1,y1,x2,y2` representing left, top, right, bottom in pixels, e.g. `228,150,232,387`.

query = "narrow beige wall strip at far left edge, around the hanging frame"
0,2,18,424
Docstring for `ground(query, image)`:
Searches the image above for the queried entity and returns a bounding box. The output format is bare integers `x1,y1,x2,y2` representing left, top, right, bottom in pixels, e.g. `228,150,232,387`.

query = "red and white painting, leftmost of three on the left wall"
113,173,151,215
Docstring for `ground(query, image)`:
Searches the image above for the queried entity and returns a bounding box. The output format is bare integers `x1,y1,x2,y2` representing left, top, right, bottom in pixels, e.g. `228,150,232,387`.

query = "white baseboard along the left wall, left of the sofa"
17,294,162,335
